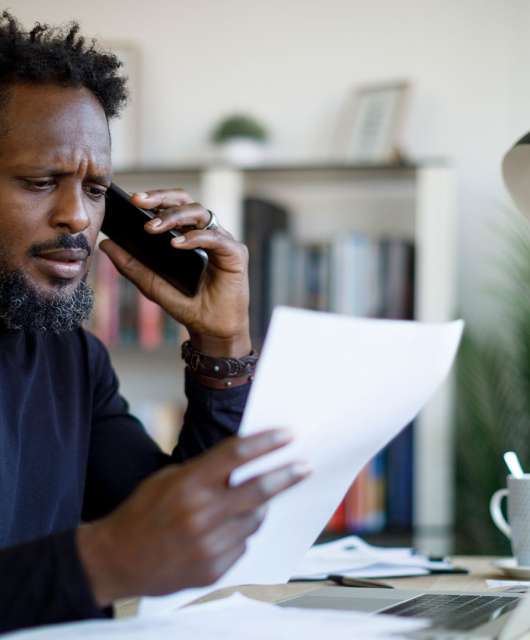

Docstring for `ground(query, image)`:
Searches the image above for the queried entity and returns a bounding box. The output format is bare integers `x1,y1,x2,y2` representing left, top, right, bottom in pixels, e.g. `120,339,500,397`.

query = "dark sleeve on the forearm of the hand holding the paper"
0,529,110,633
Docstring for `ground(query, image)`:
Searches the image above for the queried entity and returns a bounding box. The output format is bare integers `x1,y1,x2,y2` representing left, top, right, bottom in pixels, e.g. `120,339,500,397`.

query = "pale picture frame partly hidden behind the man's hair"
99,40,142,170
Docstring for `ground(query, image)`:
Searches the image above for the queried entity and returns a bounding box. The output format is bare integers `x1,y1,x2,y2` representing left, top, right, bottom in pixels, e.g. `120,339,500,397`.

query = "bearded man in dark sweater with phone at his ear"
0,13,307,631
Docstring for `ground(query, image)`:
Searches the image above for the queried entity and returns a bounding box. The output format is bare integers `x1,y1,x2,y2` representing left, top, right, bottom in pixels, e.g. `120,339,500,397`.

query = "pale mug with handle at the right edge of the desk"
490,473,530,566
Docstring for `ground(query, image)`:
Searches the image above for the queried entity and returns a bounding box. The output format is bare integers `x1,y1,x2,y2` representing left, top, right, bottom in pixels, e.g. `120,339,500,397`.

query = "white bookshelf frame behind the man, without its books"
105,160,456,554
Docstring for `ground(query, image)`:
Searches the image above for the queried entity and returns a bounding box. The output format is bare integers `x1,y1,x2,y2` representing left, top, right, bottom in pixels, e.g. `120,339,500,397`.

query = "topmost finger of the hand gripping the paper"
189,429,293,484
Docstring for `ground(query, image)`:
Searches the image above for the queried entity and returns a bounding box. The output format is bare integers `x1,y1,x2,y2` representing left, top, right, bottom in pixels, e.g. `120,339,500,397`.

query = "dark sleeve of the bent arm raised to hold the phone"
83,334,249,520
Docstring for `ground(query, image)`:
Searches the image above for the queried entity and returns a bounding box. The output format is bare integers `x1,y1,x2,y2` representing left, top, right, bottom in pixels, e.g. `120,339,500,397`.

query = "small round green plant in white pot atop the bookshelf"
211,113,268,166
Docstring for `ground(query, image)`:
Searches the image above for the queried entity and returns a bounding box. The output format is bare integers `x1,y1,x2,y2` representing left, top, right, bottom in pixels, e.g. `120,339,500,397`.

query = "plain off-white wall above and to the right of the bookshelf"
12,0,530,322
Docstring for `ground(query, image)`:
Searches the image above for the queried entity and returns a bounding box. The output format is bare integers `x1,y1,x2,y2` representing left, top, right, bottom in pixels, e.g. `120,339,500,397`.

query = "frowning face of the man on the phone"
0,84,111,330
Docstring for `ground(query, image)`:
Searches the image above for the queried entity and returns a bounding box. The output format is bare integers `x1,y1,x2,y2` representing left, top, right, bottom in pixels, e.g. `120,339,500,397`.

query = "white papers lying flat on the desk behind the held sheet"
292,536,453,580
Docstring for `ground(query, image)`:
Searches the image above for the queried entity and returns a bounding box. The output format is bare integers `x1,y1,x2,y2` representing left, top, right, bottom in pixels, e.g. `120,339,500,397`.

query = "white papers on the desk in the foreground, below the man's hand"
5,593,426,640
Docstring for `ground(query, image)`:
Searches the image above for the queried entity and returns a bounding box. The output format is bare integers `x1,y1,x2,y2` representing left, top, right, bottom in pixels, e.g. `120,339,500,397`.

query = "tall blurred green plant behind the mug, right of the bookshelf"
456,213,530,555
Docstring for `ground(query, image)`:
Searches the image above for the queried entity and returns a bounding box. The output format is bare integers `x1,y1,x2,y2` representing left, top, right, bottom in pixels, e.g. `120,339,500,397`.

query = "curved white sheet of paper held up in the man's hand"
140,307,463,615
